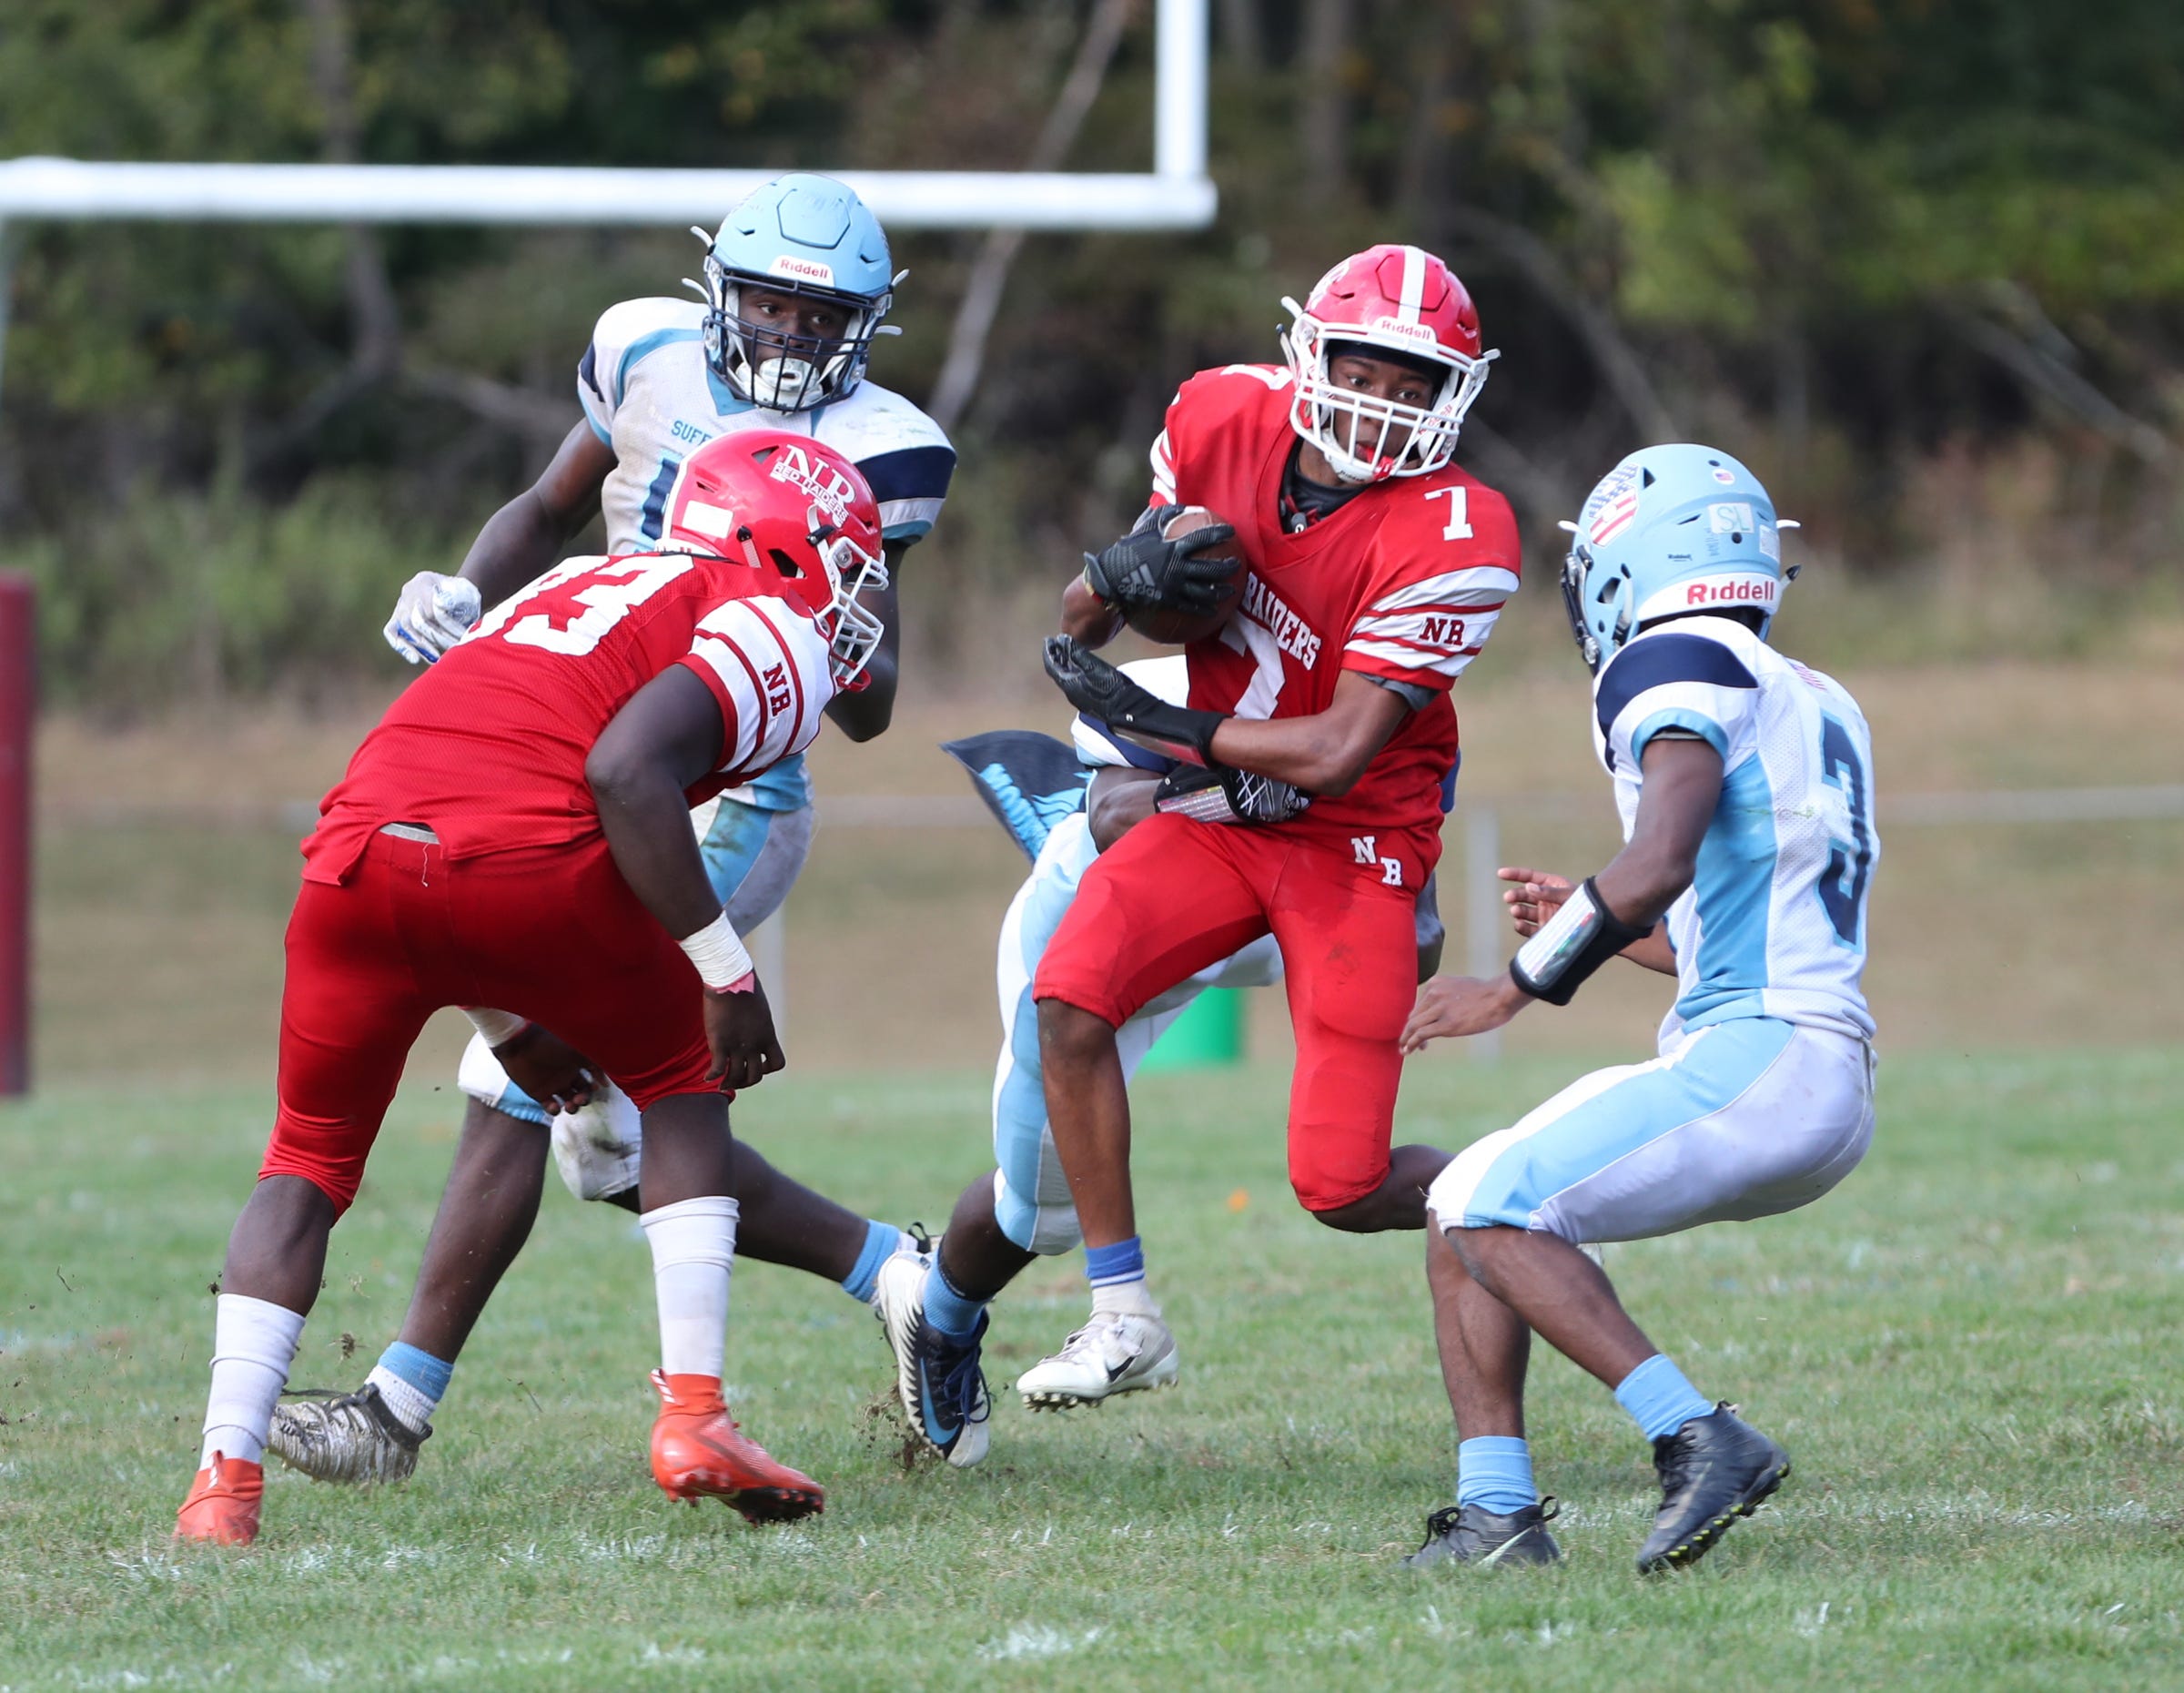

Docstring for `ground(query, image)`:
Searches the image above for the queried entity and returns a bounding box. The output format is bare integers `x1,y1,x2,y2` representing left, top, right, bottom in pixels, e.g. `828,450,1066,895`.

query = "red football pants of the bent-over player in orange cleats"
258,835,714,1212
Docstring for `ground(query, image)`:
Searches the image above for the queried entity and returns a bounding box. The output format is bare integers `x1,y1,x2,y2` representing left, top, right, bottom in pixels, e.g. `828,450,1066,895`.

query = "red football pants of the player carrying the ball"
1031,815,1418,1211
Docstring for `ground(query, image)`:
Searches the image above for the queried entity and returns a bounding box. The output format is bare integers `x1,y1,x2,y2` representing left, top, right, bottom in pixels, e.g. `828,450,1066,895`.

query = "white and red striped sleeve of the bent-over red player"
679,596,834,782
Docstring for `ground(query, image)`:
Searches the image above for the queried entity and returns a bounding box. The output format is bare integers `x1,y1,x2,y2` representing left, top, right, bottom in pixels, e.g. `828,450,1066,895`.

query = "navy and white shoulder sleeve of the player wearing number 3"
1592,618,1760,776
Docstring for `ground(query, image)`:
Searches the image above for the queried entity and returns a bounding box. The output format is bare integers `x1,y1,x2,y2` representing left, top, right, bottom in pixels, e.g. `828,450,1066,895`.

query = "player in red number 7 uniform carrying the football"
1017,245,1518,1407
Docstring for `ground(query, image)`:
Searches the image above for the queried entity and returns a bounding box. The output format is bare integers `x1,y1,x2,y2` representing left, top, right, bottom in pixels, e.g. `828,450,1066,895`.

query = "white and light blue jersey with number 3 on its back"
1592,618,1880,1039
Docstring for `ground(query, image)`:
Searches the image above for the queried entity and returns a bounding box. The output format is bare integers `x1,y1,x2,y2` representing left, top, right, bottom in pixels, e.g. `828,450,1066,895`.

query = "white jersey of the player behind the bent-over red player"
577,299,955,553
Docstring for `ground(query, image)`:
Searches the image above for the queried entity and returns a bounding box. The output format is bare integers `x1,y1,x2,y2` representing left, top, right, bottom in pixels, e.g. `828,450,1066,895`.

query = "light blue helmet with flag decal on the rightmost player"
1562,443,1795,673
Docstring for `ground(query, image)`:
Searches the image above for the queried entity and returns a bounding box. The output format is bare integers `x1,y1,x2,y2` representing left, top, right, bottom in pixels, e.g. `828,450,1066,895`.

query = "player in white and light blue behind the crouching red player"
273,175,955,1481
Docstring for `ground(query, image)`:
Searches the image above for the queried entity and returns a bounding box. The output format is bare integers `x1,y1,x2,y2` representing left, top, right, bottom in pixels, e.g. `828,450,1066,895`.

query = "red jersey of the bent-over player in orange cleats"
304,553,834,883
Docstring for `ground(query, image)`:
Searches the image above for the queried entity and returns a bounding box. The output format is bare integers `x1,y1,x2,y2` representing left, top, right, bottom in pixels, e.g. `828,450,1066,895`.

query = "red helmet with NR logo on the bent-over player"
660,428,886,693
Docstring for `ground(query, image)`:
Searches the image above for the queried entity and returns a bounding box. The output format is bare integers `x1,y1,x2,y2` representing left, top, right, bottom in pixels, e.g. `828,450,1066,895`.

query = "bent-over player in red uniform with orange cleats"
175,431,886,1545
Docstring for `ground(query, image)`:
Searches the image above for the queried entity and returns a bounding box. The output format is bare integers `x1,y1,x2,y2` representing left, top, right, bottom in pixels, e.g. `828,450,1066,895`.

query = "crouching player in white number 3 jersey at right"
1404,446,1880,1571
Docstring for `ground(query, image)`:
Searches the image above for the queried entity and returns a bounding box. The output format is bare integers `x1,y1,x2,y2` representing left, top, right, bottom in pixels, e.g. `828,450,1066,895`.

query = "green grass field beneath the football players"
0,1050,2184,1691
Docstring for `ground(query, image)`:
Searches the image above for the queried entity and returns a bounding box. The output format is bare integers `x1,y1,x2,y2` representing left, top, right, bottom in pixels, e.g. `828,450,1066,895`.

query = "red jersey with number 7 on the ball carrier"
1153,365,1518,889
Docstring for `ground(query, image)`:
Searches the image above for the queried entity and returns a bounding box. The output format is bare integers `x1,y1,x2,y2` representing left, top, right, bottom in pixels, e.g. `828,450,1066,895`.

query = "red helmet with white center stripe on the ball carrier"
1282,245,1498,482
